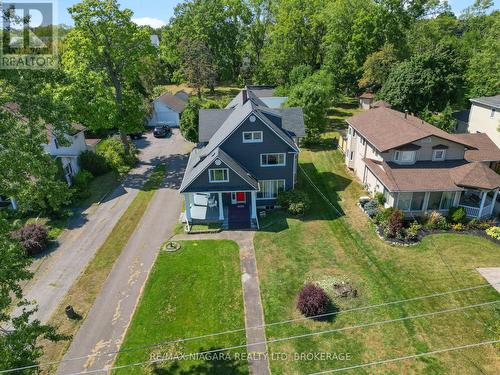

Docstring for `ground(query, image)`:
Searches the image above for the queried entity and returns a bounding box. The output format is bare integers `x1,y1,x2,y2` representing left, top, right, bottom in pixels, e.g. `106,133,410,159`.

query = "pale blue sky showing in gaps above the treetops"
52,0,499,27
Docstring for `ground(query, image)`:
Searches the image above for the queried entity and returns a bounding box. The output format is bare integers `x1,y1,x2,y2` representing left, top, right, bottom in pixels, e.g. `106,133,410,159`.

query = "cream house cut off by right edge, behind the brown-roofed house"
467,95,500,147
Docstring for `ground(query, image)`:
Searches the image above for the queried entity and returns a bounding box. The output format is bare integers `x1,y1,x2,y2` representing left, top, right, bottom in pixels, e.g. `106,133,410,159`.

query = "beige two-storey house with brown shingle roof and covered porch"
345,106,500,218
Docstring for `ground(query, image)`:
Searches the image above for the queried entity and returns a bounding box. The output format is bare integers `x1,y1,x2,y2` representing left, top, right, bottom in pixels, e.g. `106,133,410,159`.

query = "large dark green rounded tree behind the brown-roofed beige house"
377,45,464,113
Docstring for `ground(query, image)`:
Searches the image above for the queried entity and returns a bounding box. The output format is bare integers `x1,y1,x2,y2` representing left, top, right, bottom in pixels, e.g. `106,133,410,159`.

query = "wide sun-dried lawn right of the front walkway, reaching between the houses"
255,103,500,374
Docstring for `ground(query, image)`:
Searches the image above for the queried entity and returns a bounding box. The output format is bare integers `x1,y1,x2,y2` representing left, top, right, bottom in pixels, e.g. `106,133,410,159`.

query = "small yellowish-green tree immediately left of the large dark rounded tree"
358,44,398,91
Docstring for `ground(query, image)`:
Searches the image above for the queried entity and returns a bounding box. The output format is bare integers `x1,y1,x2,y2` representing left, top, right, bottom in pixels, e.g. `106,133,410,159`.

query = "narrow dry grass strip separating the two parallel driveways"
40,164,166,373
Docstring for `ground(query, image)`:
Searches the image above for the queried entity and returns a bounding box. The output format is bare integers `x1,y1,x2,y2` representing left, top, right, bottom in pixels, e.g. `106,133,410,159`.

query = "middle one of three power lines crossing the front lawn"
63,300,500,375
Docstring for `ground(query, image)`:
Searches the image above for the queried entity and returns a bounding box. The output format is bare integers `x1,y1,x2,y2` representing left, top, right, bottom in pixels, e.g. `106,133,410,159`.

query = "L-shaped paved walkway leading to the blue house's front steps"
174,231,271,375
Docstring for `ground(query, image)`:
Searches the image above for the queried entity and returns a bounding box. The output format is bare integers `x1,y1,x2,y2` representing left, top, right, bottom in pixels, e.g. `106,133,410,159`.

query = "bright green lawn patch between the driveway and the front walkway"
115,241,248,375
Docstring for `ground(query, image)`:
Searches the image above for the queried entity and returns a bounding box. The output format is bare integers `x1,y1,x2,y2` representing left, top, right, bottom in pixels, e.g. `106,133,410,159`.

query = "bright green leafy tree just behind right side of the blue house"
286,71,336,143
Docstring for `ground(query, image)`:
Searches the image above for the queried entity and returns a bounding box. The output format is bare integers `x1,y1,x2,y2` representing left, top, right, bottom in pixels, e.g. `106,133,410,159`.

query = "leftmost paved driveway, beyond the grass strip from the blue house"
14,132,187,322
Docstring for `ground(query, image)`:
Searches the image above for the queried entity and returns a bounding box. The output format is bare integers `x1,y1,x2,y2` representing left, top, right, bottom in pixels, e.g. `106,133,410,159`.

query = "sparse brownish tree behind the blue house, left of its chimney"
179,39,217,99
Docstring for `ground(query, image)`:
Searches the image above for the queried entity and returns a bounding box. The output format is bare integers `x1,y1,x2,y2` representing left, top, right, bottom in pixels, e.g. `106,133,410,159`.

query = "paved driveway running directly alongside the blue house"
57,130,189,374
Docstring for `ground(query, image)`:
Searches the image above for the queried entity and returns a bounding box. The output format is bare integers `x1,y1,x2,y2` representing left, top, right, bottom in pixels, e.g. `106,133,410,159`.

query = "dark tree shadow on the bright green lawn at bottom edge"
151,348,248,375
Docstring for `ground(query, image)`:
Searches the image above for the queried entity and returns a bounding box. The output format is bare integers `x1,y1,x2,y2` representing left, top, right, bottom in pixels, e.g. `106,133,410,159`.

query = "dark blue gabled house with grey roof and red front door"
180,86,305,229
